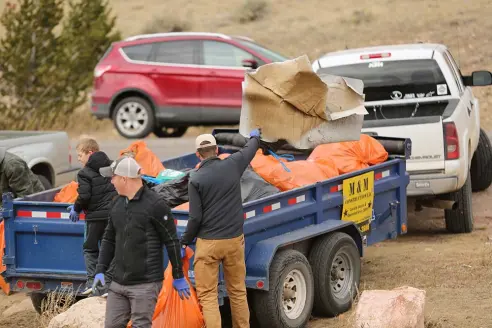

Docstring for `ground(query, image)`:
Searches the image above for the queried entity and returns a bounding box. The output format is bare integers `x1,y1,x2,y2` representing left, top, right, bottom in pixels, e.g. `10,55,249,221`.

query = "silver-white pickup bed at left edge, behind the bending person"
0,130,80,189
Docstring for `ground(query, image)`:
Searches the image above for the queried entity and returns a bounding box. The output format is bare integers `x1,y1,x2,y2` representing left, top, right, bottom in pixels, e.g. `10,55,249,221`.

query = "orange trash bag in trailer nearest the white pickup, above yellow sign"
308,134,388,174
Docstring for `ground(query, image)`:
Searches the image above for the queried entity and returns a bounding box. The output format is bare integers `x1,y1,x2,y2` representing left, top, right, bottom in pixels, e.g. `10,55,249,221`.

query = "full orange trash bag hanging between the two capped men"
127,247,205,328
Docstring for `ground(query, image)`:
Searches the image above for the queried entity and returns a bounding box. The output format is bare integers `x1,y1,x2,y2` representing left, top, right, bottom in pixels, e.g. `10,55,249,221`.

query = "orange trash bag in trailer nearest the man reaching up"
251,150,338,191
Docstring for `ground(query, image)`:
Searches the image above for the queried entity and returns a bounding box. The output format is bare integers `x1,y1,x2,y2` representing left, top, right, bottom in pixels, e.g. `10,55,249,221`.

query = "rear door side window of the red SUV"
152,40,198,65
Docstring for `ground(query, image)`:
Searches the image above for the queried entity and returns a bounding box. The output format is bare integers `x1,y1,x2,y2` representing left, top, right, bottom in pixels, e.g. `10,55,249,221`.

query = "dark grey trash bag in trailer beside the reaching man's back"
241,166,280,203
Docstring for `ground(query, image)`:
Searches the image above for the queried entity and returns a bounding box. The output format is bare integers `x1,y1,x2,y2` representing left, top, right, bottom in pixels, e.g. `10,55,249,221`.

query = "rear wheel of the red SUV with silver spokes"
113,97,154,139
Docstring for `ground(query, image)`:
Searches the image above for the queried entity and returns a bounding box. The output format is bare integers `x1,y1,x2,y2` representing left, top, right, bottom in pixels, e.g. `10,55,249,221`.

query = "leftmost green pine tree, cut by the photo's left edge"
0,0,63,129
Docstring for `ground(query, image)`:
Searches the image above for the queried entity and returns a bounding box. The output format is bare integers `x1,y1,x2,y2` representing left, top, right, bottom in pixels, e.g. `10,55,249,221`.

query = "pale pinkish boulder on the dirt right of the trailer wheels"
355,286,425,328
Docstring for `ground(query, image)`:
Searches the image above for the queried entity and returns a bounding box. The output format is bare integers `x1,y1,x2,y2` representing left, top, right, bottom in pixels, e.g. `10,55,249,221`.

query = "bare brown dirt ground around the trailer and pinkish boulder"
0,189,492,328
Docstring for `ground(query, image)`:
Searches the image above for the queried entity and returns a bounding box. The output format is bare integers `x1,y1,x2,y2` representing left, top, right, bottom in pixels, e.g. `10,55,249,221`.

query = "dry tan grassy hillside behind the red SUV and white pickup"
0,0,492,130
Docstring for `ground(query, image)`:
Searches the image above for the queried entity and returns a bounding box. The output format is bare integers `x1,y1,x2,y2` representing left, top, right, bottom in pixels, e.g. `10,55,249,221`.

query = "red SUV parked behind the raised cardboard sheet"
91,32,287,138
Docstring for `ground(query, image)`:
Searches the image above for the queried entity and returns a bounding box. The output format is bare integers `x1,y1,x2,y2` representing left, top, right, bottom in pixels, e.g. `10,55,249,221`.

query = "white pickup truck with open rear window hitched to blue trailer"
313,43,492,233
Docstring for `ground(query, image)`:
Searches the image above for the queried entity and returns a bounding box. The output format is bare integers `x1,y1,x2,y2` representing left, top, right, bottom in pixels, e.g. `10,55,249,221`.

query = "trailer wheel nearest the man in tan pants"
253,249,314,328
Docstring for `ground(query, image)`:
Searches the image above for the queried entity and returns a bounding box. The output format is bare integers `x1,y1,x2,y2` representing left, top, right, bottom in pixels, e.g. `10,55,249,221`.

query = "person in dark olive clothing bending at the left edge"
0,147,44,207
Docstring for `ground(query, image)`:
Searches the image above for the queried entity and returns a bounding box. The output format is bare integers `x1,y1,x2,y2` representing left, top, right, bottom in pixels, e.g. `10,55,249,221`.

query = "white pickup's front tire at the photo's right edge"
470,129,492,191
